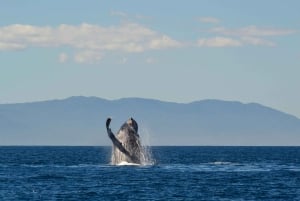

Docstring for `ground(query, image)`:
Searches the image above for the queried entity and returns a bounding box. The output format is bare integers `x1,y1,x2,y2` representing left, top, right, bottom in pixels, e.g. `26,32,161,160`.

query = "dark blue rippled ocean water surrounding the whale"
0,147,300,201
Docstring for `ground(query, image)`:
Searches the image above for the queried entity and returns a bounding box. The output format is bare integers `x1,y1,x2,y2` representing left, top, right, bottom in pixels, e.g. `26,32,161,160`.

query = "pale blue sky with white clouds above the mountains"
0,0,300,117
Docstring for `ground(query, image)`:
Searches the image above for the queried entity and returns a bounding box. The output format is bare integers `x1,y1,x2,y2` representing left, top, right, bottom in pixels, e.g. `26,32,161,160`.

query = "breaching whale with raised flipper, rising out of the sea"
106,118,144,165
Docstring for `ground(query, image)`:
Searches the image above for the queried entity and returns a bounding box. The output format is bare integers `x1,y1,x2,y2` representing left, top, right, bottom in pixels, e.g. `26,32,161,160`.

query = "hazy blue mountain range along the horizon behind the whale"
0,97,300,146
